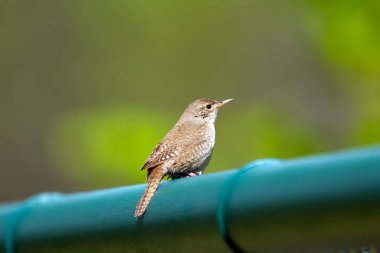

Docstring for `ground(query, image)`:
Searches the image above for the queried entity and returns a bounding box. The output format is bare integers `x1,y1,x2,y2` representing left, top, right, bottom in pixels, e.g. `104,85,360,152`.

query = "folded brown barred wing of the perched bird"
141,141,176,170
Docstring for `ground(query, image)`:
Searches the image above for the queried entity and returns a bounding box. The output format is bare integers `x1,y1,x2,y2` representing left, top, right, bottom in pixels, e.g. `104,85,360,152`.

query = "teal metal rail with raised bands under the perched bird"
0,146,380,253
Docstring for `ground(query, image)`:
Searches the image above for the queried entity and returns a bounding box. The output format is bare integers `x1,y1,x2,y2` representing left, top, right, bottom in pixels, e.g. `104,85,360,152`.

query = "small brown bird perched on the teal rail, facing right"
135,99,233,217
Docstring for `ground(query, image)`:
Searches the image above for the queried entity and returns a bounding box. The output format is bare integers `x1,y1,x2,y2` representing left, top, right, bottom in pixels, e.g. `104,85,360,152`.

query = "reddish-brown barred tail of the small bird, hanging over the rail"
135,166,164,217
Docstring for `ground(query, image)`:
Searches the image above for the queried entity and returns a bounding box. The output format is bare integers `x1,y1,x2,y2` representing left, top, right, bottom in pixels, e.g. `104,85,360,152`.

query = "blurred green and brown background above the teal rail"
0,0,380,201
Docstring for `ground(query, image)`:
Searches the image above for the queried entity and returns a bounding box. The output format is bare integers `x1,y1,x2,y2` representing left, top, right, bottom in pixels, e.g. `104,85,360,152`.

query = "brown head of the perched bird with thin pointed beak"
181,98,233,124
